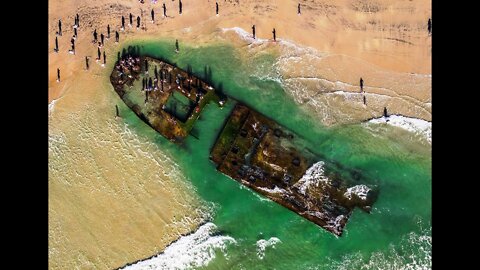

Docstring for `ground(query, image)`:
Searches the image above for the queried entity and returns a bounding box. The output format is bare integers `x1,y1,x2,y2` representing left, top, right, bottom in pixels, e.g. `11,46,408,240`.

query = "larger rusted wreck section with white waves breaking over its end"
210,104,376,236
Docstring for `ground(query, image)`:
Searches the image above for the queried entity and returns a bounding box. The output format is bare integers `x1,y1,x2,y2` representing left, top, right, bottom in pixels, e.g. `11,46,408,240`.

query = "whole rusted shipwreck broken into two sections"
110,53,377,236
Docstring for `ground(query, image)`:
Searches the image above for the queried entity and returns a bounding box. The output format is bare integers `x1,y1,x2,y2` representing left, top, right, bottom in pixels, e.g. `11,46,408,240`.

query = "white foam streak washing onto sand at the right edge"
368,115,432,143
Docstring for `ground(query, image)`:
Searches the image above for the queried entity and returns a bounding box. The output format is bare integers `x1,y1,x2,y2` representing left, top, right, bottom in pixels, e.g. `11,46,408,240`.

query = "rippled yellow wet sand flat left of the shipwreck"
49,60,207,269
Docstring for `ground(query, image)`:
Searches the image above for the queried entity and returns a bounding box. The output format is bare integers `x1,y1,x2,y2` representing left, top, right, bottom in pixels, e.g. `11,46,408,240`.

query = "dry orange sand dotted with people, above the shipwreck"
49,0,431,120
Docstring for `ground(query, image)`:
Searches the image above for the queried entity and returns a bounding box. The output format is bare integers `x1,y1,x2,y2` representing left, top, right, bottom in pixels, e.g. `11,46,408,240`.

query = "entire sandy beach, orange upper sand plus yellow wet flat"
48,0,432,269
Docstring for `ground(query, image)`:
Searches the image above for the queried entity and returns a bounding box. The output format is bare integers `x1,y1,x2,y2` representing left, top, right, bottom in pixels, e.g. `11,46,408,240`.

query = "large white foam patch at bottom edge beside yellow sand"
122,222,236,270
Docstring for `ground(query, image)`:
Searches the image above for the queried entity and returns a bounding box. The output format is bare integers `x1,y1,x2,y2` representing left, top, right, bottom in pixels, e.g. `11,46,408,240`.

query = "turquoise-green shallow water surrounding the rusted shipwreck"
119,41,431,269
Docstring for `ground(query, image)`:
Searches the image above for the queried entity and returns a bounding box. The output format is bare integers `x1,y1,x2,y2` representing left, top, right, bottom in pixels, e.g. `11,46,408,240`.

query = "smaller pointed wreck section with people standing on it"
110,53,221,143
